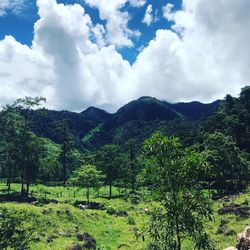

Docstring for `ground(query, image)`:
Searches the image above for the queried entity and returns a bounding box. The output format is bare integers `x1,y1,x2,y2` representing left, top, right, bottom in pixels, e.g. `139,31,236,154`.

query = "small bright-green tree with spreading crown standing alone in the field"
71,165,104,203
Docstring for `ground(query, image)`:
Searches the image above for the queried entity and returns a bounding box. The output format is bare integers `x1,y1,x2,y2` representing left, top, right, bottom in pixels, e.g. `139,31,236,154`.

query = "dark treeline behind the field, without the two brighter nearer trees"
0,87,250,197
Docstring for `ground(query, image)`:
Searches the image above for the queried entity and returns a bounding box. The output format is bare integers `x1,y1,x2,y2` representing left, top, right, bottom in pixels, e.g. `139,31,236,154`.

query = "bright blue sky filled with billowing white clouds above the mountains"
0,0,250,112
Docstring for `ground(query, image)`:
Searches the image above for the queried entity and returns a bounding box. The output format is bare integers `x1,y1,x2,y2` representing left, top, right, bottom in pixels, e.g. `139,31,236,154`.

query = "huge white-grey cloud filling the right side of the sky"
133,0,250,101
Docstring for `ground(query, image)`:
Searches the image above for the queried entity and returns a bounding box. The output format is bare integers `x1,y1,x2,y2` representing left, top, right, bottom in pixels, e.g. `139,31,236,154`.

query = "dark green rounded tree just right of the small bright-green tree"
95,144,125,198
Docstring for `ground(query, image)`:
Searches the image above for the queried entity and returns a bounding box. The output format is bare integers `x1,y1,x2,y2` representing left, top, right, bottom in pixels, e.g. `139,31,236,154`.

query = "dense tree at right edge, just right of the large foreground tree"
204,131,250,194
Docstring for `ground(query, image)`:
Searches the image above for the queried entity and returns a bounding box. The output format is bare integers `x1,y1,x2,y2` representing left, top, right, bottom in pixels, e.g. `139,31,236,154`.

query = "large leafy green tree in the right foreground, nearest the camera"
143,133,212,250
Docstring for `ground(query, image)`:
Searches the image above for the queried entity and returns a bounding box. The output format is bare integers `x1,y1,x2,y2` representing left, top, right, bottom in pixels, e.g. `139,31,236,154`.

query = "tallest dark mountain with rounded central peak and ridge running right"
82,96,220,149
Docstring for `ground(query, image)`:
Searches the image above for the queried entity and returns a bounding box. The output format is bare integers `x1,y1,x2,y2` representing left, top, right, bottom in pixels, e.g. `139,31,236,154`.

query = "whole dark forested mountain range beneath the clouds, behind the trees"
22,97,220,149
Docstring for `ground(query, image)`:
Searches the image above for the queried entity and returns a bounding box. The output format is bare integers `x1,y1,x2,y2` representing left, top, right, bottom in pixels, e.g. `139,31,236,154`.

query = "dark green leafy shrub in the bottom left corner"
0,208,29,250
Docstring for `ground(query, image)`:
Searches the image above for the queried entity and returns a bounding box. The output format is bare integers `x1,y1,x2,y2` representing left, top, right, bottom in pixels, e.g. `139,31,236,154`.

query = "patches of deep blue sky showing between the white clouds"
0,0,182,64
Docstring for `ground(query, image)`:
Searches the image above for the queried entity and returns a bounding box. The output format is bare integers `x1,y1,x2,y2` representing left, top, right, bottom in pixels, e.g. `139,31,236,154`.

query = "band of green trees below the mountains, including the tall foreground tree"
0,87,250,250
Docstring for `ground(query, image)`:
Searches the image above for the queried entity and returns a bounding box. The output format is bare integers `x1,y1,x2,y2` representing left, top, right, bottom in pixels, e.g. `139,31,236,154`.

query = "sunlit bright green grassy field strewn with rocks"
0,183,250,250
